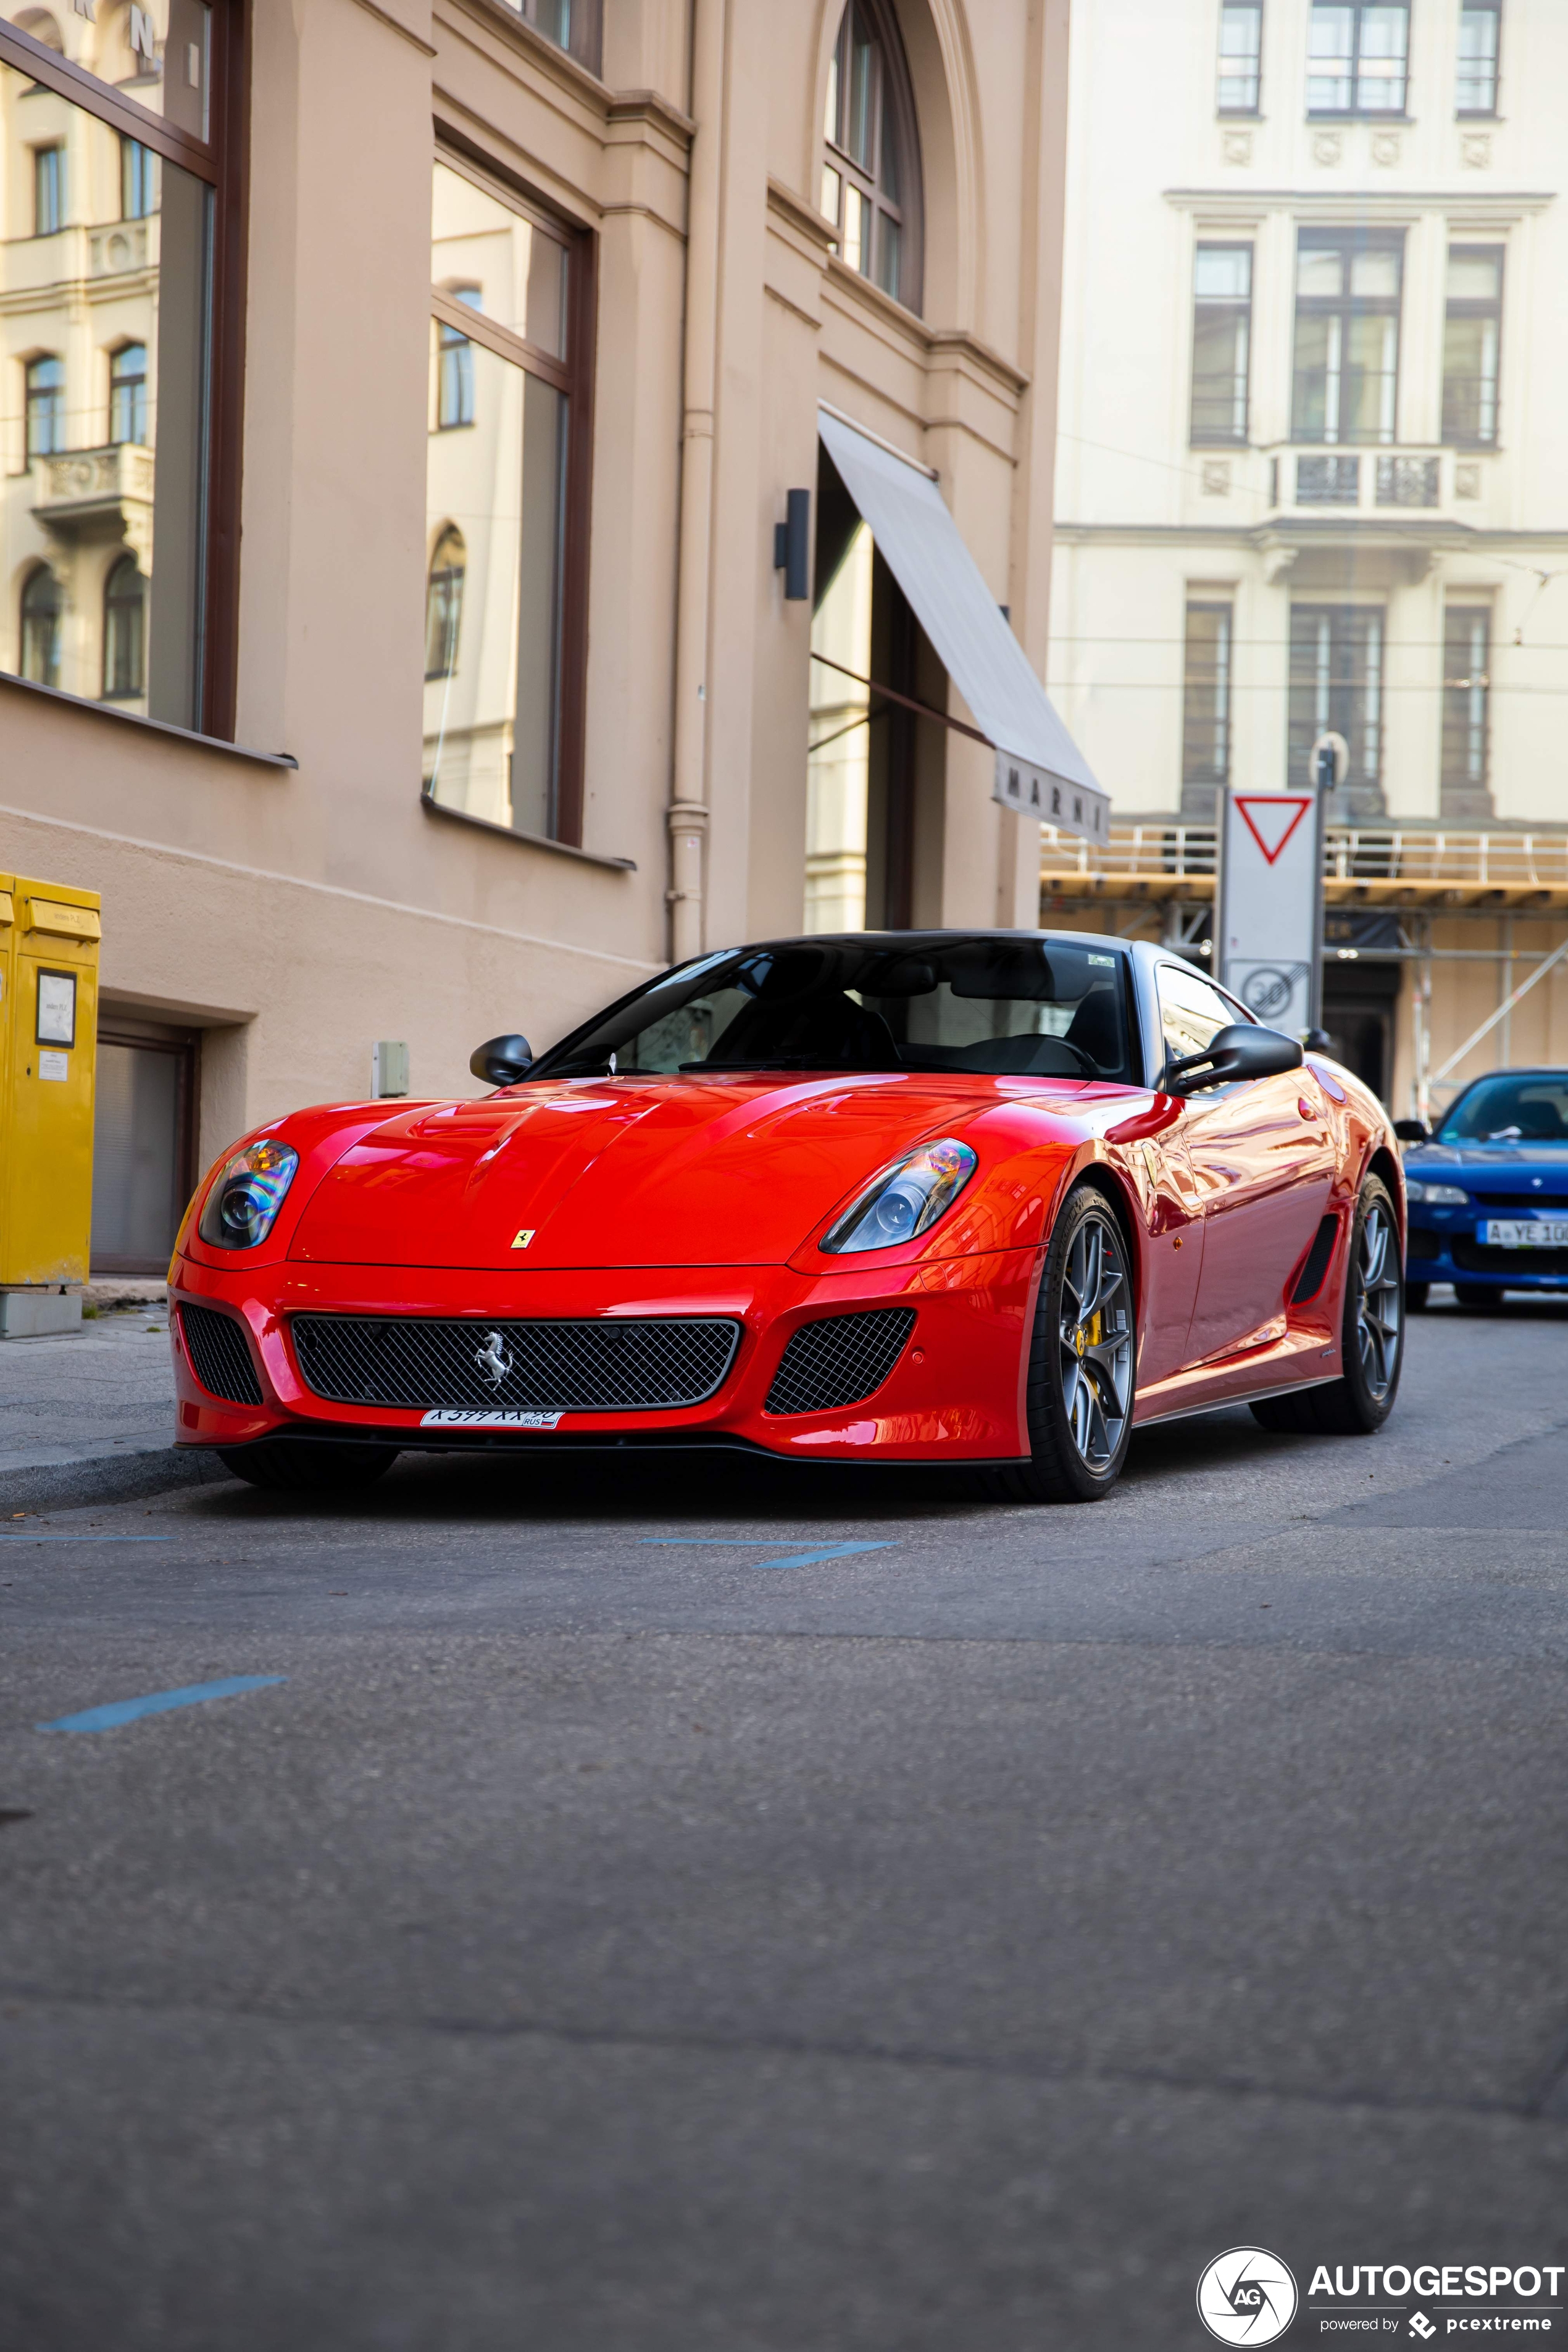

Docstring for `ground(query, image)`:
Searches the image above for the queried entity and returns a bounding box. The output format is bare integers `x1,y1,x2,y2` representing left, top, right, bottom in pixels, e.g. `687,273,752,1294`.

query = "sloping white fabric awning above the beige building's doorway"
818,409,1109,842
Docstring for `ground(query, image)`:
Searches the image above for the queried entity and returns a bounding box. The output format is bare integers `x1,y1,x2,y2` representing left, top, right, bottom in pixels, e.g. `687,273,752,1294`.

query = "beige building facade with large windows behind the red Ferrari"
0,0,1067,1268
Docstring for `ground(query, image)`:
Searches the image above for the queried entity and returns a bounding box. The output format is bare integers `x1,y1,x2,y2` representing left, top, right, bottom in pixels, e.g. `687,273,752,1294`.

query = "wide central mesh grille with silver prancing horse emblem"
289,1315,741,1414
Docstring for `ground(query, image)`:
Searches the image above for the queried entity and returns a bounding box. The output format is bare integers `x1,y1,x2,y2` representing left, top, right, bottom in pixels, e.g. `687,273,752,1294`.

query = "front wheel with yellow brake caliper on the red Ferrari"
992,1183,1138,1503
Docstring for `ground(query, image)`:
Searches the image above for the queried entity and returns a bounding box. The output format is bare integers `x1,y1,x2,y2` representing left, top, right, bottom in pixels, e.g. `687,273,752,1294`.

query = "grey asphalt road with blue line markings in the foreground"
0,1307,1568,2352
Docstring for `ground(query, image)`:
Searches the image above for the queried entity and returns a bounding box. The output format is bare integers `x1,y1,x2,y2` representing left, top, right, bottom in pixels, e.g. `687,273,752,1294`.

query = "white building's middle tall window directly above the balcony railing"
1291,228,1403,442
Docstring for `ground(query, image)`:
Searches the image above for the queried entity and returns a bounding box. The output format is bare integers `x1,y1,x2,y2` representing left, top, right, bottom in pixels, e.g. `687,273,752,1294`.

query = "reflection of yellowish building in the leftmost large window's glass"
0,55,212,727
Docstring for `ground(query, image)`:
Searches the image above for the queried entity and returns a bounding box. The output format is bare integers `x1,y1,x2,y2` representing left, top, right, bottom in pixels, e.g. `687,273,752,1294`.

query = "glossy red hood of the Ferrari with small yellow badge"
289,1075,1084,1272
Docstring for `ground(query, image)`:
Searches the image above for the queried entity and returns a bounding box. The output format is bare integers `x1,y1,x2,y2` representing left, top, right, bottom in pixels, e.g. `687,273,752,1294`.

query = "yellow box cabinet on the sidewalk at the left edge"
0,875,101,1338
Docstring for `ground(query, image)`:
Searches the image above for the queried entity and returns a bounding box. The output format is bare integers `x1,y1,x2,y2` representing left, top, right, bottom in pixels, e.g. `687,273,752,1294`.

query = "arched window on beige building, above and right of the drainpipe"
820,0,919,311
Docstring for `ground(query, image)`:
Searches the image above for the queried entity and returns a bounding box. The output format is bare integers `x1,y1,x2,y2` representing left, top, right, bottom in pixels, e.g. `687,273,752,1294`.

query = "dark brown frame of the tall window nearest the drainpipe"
421,133,599,849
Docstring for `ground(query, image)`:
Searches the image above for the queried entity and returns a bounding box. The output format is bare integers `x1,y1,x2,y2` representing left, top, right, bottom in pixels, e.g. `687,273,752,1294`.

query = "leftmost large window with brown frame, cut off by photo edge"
0,0,244,736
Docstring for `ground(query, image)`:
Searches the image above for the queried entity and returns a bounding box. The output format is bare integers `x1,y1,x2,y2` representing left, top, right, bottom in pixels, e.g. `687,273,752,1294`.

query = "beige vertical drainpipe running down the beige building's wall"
665,0,729,964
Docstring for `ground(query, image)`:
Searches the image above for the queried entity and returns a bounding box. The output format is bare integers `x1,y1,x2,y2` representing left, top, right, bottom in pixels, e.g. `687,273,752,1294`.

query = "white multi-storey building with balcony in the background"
1048,0,1568,828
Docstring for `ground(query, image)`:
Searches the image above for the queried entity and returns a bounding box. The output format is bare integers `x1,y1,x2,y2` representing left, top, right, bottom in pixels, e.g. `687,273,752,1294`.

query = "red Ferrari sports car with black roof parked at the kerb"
169,932,1406,1501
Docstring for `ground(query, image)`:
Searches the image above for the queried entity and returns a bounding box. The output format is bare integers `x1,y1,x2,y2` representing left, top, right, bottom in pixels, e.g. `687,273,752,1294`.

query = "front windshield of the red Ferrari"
529,932,1133,1082
